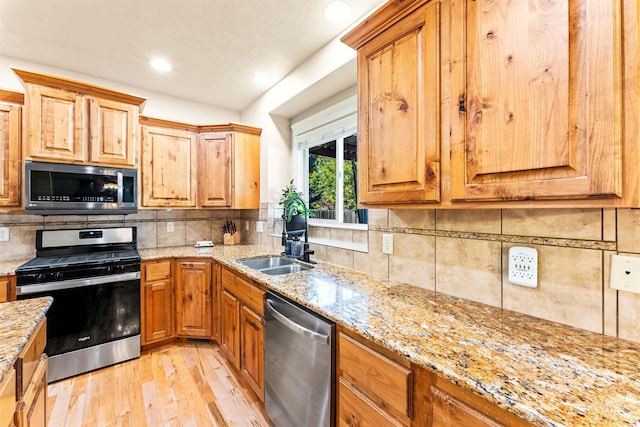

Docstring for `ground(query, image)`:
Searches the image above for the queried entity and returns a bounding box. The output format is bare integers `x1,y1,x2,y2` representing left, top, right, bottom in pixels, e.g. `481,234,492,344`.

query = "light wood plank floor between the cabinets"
47,343,271,427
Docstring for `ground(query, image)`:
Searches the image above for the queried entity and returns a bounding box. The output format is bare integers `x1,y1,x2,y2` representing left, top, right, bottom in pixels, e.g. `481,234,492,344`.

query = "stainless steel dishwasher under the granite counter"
264,291,335,427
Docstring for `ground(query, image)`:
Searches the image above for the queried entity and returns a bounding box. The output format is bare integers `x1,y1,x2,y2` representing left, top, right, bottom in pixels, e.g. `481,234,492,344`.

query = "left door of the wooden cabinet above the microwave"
25,85,86,162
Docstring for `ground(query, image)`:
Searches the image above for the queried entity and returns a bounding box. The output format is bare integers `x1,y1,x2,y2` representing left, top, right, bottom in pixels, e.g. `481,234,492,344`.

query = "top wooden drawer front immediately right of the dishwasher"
338,334,412,421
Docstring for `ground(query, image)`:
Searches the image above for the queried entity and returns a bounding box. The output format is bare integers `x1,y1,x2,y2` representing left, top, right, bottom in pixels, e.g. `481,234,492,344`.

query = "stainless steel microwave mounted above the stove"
25,161,138,215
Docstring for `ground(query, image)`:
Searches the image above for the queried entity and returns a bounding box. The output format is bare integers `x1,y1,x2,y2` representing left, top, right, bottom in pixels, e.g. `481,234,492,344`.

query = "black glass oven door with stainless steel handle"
16,271,140,381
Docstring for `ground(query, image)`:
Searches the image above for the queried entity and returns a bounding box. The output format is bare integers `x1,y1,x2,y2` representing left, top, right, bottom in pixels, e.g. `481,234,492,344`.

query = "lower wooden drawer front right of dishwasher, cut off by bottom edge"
338,378,402,427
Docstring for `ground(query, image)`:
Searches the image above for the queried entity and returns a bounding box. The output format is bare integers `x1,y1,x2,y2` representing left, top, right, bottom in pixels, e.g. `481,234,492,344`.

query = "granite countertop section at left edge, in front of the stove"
0,297,53,383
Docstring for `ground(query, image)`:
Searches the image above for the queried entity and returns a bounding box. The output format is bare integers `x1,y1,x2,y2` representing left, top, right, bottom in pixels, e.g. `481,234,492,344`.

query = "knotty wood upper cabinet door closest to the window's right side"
358,2,440,204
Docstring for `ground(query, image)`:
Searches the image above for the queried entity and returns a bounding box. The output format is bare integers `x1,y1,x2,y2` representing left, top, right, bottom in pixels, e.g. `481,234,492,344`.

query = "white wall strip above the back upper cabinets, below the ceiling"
0,56,240,125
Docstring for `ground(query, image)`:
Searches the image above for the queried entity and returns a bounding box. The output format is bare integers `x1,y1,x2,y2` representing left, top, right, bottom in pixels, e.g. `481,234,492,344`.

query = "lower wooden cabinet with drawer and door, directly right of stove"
140,259,175,345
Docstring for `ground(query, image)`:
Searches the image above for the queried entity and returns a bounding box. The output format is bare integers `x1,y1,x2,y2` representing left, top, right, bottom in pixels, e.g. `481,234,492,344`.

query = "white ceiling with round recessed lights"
0,0,381,111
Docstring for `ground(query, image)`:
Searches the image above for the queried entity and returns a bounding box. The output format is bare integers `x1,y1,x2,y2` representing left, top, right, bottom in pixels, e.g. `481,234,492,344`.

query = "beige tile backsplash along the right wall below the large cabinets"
259,209,640,342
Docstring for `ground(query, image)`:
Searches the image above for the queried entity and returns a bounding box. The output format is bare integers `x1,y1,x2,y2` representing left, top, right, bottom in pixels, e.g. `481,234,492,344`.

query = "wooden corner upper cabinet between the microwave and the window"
140,116,261,209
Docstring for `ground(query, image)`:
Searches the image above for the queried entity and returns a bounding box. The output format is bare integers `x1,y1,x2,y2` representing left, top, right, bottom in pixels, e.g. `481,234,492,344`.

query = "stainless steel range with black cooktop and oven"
16,227,140,382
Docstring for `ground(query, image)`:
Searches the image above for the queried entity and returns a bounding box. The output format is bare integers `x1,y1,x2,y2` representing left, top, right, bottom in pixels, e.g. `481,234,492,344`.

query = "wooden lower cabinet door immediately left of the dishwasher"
240,305,264,401
